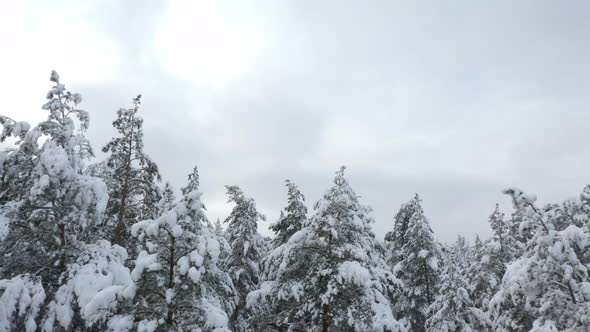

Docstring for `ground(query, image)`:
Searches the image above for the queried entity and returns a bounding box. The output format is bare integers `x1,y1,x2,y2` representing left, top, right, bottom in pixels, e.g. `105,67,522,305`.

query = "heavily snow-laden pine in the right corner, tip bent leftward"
490,188,590,332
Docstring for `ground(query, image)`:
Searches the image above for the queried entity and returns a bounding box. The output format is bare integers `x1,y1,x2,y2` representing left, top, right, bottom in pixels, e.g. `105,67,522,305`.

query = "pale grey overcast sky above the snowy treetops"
0,0,590,241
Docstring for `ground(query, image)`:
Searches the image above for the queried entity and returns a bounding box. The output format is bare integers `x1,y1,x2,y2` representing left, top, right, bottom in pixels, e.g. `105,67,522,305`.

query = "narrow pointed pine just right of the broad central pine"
394,195,440,331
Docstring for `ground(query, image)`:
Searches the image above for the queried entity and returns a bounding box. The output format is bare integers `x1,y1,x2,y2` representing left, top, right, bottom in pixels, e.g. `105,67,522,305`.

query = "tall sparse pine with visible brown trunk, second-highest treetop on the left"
102,95,160,245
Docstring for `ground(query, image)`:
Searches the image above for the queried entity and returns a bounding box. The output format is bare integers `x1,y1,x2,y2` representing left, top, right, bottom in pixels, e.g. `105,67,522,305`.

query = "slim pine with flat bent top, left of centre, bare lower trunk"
223,186,266,332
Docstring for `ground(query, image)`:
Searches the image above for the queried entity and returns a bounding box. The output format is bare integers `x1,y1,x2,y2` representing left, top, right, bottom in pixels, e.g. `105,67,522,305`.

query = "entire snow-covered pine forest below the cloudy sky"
0,71,590,332
